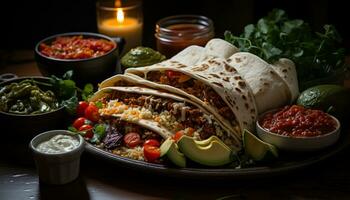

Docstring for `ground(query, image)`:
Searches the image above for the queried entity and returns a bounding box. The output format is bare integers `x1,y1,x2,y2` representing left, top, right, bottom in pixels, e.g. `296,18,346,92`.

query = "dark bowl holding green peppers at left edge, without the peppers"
0,76,67,143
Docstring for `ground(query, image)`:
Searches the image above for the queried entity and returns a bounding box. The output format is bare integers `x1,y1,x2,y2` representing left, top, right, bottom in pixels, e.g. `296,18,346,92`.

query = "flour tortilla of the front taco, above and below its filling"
89,86,242,151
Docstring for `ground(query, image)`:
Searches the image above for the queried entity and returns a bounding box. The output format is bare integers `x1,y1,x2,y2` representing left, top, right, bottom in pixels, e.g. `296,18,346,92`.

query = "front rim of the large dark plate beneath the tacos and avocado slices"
86,126,350,179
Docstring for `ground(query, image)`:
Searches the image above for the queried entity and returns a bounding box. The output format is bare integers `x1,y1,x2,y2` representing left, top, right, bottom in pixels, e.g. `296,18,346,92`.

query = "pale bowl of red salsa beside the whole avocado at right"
256,105,340,151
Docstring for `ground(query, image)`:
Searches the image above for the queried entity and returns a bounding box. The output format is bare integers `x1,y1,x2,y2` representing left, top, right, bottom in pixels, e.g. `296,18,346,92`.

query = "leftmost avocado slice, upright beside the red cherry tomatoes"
160,138,186,167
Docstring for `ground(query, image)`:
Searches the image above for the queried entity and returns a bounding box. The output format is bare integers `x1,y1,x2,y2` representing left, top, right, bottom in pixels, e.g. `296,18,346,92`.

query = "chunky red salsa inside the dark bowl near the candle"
39,35,115,59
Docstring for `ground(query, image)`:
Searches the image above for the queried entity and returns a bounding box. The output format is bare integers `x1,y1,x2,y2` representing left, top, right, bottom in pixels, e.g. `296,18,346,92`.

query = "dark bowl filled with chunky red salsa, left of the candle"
35,32,123,84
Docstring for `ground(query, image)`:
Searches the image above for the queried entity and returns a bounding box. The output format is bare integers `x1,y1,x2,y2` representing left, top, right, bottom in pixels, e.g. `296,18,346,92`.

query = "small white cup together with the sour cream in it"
29,130,84,184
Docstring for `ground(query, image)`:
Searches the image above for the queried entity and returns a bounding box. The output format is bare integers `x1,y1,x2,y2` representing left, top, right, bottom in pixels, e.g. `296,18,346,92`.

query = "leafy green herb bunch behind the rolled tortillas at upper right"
225,9,346,88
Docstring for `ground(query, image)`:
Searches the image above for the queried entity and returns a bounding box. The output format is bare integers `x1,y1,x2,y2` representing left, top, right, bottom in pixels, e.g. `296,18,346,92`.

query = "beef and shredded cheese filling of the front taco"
100,91,235,147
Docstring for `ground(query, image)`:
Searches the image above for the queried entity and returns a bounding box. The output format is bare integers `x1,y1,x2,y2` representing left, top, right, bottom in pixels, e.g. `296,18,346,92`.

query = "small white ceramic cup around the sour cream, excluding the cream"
29,130,85,184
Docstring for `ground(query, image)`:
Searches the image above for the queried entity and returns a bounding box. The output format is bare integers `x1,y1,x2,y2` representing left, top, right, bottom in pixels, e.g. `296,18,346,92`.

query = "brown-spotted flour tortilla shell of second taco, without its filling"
122,58,257,138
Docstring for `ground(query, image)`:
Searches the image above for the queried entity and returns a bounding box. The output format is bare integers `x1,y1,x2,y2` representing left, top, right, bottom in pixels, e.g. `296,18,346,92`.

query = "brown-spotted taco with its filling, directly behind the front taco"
100,58,257,141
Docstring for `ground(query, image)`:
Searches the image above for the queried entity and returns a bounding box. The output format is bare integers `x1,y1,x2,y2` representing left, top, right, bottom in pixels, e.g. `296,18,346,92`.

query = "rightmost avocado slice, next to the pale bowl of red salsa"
243,130,278,161
